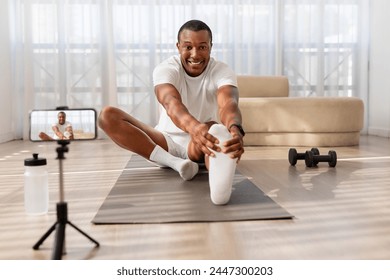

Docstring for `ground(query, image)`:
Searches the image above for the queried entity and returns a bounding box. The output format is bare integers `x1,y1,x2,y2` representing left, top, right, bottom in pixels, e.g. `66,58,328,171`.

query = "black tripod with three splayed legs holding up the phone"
33,140,100,260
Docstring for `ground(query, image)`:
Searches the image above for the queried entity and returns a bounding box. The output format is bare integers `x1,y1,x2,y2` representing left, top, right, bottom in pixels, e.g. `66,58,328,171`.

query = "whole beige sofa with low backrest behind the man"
237,76,364,147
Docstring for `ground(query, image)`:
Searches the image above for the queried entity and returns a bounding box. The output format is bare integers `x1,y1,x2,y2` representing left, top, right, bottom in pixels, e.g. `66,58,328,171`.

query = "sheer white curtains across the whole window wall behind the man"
9,0,369,138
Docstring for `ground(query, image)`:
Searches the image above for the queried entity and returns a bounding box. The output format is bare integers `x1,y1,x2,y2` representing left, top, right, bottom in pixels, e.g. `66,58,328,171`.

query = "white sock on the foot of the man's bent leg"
149,145,199,181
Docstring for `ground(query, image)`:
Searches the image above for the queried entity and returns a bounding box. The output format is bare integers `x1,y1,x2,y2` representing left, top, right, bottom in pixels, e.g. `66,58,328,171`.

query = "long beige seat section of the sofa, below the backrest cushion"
239,97,364,133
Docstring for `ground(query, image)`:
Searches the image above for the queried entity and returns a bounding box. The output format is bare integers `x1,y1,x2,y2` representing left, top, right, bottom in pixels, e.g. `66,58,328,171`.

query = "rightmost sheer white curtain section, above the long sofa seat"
282,0,369,98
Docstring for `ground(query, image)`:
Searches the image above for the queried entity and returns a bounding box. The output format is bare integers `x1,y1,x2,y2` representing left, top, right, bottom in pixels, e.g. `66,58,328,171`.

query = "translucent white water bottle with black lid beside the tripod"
24,154,49,215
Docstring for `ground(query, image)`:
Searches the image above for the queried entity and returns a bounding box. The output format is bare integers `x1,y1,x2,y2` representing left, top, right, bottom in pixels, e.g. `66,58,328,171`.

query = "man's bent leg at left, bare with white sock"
99,107,198,180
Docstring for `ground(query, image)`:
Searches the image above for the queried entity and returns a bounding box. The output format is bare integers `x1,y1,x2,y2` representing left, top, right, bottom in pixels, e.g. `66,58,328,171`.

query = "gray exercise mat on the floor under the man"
92,155,292,224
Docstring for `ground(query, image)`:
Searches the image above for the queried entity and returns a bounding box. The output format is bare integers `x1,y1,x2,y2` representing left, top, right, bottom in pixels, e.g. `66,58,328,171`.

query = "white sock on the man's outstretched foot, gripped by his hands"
209,124,237,205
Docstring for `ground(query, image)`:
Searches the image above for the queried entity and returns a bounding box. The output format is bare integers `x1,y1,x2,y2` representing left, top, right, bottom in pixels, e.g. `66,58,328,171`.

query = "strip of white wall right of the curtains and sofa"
368,0,390,137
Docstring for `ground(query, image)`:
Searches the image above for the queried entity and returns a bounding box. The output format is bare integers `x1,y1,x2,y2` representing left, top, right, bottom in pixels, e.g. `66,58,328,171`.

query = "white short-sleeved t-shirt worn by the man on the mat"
153,56,237,145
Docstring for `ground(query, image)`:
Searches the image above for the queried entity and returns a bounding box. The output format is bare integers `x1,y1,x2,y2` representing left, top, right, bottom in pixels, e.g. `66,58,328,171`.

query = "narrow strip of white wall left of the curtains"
0,0,14,143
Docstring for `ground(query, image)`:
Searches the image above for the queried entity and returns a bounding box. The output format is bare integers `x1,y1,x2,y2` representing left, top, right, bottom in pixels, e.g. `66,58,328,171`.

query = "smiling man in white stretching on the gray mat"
99,20,245,204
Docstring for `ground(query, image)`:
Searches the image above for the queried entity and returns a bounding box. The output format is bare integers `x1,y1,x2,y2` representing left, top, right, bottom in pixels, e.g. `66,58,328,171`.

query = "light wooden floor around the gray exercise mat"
0,136,390,260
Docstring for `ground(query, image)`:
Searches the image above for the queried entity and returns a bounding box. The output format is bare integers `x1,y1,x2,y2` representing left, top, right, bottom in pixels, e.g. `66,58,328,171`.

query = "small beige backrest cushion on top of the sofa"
237,75,289,98
